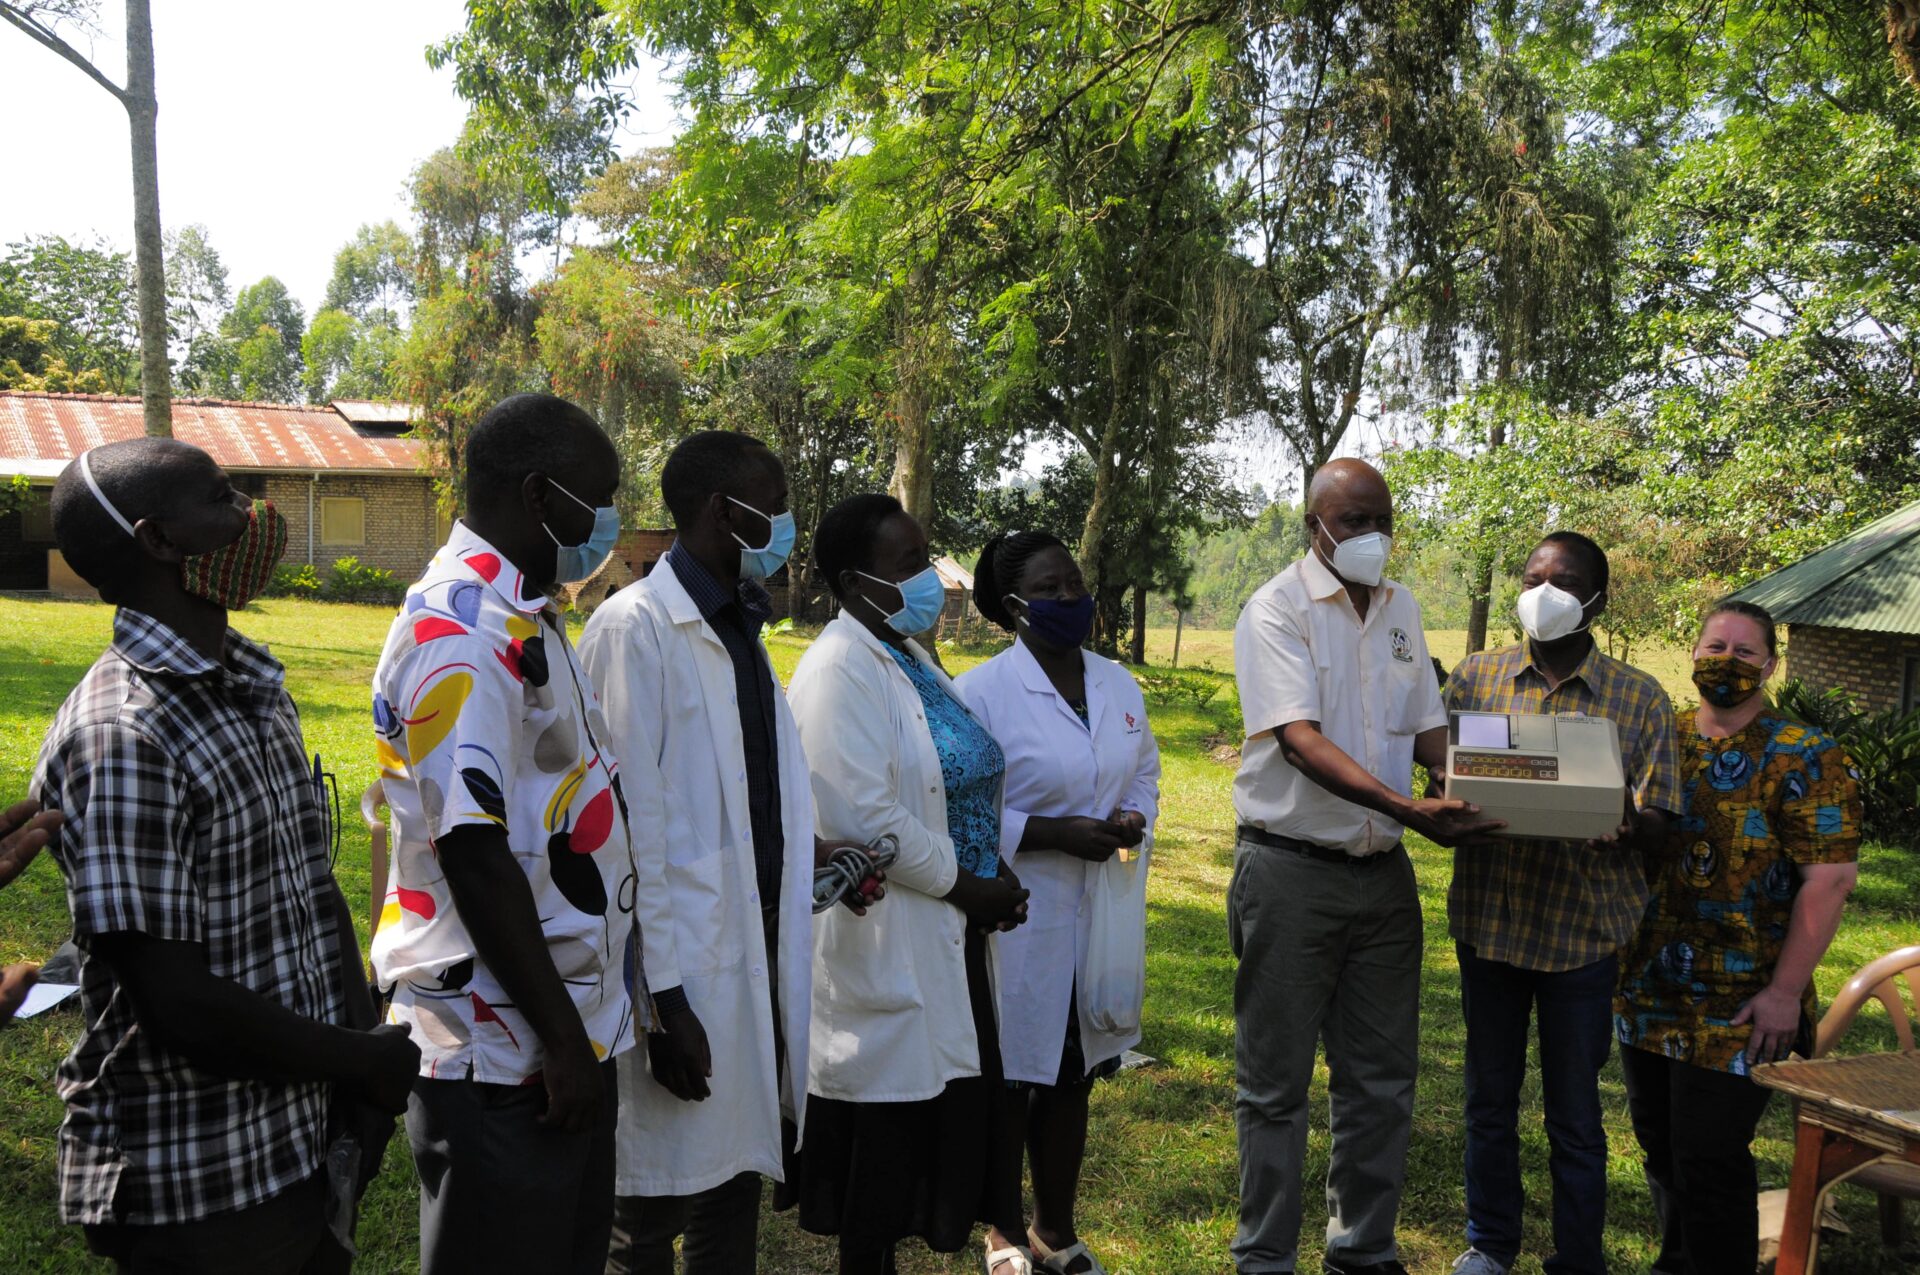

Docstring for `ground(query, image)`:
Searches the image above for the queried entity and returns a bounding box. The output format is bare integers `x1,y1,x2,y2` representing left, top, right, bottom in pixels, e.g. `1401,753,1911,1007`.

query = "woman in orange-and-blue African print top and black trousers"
1615,603,1860,1275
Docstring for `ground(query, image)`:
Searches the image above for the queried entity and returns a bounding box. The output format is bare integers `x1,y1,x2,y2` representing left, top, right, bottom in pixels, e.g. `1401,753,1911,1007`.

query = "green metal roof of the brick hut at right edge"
1734,501,1920,634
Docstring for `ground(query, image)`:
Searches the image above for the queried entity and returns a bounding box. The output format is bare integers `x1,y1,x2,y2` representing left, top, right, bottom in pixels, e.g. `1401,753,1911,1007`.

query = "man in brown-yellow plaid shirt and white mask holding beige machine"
1446,532,1680,1275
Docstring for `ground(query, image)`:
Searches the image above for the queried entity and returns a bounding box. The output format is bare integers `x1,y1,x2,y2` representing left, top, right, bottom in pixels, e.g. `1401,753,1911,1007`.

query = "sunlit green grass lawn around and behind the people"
0,599,1920,1275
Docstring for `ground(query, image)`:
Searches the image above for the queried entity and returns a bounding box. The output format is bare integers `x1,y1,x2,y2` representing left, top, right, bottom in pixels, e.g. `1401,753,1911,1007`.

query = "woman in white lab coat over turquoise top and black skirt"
787,495,1031,1275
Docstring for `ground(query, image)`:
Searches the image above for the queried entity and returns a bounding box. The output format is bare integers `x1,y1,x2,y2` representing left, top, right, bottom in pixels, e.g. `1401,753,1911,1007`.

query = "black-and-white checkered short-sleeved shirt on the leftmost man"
33,609,344,1225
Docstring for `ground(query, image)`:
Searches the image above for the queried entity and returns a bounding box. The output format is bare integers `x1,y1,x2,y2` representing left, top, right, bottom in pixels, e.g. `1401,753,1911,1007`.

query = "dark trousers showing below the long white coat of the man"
607,1167,760,1275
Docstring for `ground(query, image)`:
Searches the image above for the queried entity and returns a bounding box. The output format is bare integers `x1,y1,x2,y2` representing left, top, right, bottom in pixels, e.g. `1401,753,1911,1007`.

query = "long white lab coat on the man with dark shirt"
580,563,814,1196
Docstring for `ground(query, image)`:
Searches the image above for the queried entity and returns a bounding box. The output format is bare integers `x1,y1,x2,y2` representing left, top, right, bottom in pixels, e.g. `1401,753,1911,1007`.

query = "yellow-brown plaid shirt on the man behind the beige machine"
1446,643,1680,972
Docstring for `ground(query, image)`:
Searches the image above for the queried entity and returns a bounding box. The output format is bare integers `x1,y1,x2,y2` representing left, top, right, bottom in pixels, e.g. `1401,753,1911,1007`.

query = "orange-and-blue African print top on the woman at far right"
1613,709,1860,1075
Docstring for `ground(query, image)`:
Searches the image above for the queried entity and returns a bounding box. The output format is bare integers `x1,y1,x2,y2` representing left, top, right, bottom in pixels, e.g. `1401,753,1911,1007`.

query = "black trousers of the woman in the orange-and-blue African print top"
1620,1046,1772,1275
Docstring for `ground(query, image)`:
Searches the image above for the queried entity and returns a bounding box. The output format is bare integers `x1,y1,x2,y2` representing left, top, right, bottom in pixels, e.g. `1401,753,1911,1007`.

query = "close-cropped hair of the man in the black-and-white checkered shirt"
52,438,219,601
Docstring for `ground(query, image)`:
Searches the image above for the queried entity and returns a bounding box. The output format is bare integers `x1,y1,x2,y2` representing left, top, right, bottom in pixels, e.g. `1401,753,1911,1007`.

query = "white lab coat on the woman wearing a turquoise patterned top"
789,614,993,1102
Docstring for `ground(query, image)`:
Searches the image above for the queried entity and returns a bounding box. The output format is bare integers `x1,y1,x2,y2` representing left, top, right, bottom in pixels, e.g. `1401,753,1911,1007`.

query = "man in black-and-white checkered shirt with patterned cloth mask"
33,438,419,1275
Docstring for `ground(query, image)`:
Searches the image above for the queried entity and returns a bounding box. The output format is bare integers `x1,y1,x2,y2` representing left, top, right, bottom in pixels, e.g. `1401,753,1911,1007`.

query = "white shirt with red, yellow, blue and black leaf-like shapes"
372,522,636,1085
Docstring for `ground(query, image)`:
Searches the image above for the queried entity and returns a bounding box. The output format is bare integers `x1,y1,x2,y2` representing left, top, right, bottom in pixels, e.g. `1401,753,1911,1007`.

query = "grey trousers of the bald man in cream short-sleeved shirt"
1227,841,1425,1275
